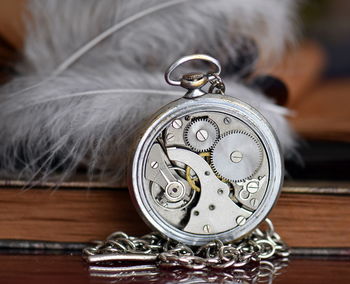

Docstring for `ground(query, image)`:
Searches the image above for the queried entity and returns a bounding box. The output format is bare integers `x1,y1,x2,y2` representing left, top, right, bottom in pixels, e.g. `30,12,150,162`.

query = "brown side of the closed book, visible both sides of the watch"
0,182,350,248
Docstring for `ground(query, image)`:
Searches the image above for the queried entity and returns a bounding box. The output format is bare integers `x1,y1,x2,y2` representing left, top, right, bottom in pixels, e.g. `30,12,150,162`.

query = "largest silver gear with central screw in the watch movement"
211,130,263,182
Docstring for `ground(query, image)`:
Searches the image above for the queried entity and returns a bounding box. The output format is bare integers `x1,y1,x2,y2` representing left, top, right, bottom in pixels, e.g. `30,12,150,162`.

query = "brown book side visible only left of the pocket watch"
0,189,148,242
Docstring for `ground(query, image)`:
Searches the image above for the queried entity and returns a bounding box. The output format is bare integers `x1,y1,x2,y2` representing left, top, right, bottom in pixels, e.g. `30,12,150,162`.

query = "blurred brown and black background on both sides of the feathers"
0,0,350,180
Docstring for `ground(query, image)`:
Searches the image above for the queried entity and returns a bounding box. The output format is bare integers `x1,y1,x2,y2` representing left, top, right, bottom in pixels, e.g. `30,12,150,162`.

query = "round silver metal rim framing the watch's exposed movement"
128,94,284,245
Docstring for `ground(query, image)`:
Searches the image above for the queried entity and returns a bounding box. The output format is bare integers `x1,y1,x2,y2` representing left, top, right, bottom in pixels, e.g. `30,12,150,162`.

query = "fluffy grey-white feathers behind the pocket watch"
0,0,295,181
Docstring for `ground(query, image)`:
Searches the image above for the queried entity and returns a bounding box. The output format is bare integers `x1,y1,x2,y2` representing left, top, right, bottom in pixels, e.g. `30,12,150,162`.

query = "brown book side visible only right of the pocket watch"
270,194,350,247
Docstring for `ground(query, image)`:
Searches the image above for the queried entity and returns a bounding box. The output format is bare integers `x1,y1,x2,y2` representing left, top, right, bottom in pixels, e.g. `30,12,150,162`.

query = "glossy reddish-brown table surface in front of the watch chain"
0,254,350,284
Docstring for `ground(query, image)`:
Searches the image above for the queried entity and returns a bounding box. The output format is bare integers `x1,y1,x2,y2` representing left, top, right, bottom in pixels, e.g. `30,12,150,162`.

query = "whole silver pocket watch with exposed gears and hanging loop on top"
128,54,284,246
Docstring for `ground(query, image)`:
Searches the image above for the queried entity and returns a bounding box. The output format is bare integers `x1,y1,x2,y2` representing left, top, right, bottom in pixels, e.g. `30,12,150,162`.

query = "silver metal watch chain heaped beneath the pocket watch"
83,219,289,271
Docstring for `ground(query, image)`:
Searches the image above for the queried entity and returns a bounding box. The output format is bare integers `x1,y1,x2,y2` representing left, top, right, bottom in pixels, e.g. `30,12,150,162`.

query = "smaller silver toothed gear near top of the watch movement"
184,118,220,152
